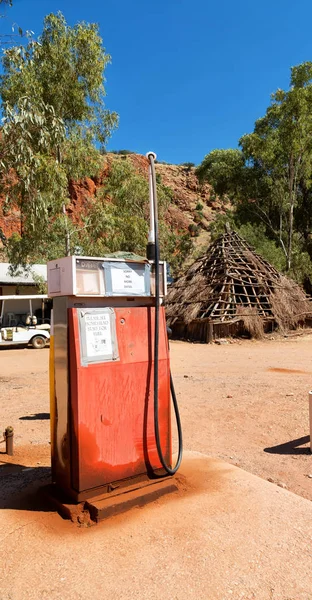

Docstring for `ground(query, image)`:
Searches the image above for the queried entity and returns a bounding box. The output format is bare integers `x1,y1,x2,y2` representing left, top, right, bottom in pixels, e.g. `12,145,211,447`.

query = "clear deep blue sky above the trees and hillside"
0,0,312,164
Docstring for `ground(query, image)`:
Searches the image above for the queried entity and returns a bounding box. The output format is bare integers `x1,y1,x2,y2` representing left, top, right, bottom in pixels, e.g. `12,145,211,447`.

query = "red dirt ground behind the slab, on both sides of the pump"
0,335,312,500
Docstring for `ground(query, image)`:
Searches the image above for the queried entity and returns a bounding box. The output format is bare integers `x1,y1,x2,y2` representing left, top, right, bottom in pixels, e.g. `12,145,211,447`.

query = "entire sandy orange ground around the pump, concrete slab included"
0,336,312,600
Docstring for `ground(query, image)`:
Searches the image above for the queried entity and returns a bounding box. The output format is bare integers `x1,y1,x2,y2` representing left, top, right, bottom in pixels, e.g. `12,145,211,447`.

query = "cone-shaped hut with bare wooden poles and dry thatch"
166,231,312,342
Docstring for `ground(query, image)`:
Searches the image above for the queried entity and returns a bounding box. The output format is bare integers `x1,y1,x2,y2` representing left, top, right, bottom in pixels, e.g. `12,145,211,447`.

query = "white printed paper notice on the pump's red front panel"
84,312,113,358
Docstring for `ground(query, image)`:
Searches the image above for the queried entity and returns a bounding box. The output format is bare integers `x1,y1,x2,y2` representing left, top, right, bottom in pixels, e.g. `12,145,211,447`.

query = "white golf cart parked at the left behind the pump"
0,295,50,349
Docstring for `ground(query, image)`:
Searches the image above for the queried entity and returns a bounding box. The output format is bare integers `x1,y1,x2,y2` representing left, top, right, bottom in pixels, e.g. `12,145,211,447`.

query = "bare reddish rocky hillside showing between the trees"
0,153,229,253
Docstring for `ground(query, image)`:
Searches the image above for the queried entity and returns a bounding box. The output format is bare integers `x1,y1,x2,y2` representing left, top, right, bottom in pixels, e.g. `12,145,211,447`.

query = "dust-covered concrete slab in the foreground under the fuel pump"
0,452,312,600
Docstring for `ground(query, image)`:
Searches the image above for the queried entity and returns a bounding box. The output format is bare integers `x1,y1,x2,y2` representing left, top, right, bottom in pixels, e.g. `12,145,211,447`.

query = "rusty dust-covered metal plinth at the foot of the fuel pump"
40,477,178,527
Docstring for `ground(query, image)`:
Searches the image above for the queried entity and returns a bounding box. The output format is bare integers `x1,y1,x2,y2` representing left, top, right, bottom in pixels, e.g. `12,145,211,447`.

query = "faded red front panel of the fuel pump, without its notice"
68,306,172,497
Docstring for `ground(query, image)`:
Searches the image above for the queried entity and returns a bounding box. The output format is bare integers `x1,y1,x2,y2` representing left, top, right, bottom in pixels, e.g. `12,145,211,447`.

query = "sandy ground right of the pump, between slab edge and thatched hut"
171,335,312,500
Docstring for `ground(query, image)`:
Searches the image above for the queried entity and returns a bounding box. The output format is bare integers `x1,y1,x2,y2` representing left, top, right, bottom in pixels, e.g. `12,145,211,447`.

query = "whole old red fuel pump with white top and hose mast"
48,153,182,520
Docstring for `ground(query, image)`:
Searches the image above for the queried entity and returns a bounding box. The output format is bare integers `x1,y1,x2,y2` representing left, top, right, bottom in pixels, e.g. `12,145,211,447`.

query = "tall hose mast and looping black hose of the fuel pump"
146,152,183,475
